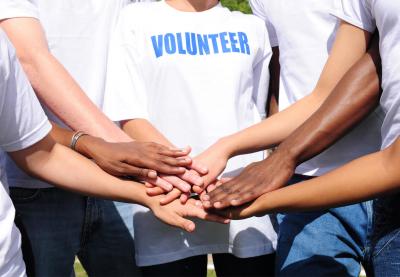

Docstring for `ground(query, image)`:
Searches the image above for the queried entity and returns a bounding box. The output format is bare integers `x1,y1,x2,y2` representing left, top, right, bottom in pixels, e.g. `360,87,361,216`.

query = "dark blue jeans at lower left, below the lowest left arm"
10,188,140,277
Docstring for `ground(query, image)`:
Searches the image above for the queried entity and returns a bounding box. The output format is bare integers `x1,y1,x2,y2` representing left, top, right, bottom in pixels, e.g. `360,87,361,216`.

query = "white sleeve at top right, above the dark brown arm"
332,0,376,33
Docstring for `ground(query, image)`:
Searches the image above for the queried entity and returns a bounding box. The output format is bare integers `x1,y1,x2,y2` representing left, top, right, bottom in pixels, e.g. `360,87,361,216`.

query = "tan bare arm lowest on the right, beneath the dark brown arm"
218,139,400,219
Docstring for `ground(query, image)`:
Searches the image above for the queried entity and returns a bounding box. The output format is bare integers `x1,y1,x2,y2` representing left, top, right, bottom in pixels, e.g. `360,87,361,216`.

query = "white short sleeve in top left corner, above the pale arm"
0,0,39,20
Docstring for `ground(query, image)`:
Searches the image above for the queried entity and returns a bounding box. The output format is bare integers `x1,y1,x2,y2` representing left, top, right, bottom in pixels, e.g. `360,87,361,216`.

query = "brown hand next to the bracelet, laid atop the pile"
76,136,192,179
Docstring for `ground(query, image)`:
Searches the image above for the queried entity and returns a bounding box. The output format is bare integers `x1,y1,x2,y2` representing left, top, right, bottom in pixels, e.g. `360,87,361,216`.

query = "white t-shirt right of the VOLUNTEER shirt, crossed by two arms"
250,0,384,176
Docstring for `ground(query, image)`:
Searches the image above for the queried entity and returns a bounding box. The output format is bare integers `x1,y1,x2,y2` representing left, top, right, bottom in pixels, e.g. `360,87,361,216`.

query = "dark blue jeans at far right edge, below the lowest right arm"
372,194,400,277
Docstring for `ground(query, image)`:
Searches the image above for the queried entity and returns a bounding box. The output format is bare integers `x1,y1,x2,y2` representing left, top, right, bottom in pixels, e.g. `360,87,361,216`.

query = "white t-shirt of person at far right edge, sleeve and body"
337,0,400,149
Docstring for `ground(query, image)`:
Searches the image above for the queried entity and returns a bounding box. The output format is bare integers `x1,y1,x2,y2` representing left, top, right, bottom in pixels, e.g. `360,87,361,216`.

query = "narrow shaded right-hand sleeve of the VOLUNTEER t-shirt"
253,23,272,118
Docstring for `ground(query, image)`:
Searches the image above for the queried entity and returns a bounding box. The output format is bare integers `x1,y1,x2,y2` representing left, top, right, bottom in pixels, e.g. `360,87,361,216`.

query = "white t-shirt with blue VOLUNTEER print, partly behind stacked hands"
104,1,276,266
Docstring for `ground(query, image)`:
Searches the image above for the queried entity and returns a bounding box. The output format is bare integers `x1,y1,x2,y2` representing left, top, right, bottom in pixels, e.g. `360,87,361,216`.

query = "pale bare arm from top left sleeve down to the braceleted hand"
0,18,130,141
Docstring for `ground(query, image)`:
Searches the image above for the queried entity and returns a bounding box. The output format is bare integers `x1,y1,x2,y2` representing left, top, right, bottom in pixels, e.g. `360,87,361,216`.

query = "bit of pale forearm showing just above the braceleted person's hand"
122,118,173,147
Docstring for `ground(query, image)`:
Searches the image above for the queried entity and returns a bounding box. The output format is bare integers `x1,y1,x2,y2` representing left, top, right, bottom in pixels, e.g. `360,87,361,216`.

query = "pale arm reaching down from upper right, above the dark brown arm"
198,22,371,188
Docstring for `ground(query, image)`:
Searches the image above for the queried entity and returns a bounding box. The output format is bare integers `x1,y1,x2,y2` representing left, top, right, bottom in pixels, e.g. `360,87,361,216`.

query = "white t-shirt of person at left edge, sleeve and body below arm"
0,29,51,277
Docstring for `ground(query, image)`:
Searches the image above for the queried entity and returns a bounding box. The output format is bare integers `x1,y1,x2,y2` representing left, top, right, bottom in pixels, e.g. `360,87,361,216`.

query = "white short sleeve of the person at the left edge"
0,32,51,152
